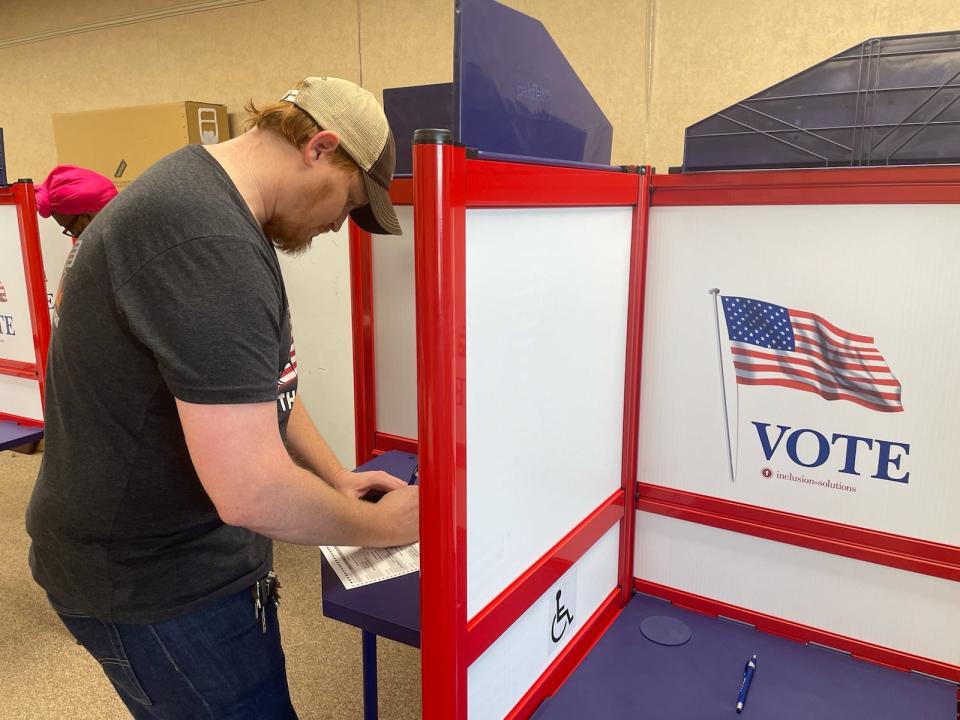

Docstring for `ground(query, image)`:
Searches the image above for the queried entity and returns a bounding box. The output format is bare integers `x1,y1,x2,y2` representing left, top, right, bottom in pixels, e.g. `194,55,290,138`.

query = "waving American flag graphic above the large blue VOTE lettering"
721,296,903,412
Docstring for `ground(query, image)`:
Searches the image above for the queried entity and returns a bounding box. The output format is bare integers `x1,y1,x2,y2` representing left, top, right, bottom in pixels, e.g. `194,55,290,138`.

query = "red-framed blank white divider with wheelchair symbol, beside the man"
344,145,647,717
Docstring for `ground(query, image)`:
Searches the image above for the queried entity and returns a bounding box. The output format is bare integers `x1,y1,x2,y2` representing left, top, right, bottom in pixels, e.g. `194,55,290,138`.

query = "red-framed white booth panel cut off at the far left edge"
0,180,50,427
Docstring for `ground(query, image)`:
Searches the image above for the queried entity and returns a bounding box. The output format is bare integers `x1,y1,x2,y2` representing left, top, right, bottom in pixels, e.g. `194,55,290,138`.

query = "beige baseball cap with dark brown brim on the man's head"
281,77,402,235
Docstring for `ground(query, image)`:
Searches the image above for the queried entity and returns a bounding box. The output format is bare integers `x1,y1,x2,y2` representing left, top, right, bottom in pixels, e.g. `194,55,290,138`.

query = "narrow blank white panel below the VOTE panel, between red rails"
634,512,960,665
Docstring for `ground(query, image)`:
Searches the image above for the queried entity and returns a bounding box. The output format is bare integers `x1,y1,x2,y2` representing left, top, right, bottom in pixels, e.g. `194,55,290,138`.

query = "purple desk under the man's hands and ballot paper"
320,451,420,647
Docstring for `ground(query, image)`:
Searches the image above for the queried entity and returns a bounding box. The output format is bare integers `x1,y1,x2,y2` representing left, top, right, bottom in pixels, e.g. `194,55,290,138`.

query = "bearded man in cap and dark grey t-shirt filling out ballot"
27,77,419,720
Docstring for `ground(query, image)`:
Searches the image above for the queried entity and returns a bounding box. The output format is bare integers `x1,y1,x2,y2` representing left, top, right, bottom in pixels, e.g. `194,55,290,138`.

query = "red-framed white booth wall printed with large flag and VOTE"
635,166,960,682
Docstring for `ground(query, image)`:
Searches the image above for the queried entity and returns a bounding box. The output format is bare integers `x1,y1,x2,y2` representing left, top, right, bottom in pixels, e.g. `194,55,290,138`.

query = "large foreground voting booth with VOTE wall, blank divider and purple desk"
325,5,960,720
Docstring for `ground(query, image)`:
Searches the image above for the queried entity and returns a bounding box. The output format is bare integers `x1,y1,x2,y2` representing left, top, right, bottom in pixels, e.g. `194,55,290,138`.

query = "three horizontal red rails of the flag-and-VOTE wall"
634,165,960,682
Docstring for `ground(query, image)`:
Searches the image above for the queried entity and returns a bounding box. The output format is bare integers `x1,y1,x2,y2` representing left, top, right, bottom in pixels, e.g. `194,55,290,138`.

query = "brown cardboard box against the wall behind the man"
53,101,230,190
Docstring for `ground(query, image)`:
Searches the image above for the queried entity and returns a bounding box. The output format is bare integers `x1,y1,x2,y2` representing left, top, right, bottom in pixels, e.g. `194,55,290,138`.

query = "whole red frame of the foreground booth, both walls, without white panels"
350,155,960,720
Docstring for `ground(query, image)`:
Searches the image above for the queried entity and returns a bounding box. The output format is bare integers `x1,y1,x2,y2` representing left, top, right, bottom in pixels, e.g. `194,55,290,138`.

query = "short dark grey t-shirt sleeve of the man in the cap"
116,237,284,404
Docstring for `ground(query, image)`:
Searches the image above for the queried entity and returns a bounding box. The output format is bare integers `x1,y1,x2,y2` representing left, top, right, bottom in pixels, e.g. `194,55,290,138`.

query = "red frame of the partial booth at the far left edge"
0,182,50,427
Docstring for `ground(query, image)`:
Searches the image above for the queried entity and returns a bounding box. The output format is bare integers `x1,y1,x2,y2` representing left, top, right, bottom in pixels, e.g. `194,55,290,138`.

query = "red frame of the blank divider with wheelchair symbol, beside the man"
350,145,649,720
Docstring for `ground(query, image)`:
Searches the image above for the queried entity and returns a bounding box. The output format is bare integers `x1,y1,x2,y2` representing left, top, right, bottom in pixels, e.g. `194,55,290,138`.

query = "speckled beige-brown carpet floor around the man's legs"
0,452,420,720
